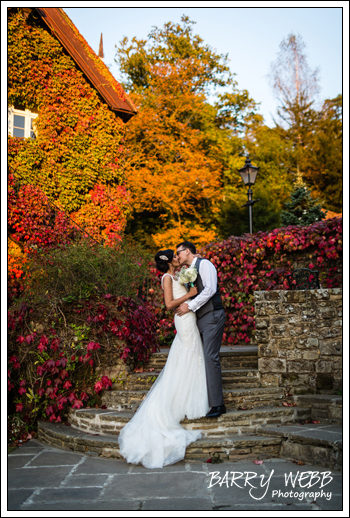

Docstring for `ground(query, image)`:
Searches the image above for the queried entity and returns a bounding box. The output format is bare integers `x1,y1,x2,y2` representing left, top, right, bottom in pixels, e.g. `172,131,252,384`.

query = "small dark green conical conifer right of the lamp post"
281,183,326,227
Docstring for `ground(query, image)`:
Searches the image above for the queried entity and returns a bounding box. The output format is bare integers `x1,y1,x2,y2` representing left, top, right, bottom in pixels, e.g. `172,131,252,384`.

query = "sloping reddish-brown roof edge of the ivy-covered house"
11,7,137,122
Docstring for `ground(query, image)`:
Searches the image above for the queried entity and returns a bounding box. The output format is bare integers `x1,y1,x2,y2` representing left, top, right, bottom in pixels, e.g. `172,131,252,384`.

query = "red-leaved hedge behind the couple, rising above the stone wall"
148,218,343,344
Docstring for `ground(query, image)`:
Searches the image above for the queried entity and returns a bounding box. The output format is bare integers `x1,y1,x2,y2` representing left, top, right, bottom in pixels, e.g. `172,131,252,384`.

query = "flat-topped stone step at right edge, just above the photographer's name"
257,423,343,471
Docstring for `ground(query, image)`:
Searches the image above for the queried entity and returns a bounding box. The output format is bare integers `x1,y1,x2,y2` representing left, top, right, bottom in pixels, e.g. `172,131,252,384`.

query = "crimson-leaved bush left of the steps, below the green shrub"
8,294,156,432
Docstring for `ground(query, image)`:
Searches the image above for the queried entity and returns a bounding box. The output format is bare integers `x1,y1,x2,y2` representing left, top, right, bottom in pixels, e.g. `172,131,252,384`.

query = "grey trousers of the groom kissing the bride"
197,309,226,407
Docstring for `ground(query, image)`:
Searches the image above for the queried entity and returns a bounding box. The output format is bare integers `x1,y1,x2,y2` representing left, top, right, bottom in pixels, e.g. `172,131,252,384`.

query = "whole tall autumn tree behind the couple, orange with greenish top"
116,16,256,249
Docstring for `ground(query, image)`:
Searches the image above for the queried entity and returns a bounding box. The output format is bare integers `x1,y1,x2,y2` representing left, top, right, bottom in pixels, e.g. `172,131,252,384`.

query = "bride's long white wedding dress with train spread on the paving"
118,274,209,468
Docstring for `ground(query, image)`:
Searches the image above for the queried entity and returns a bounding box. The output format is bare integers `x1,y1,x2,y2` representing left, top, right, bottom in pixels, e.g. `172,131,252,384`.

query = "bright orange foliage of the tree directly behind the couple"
126,63,222,248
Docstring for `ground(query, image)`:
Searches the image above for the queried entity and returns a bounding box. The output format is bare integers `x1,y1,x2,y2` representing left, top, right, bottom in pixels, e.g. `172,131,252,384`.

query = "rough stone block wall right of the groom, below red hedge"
254,288,342,394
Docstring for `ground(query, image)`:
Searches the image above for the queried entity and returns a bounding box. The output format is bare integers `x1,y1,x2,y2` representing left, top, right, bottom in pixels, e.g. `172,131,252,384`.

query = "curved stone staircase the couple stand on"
39,346,341,467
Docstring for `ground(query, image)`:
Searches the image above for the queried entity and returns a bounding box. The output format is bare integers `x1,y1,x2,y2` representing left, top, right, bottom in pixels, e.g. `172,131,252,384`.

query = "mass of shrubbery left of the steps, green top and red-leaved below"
8,236,156,433
